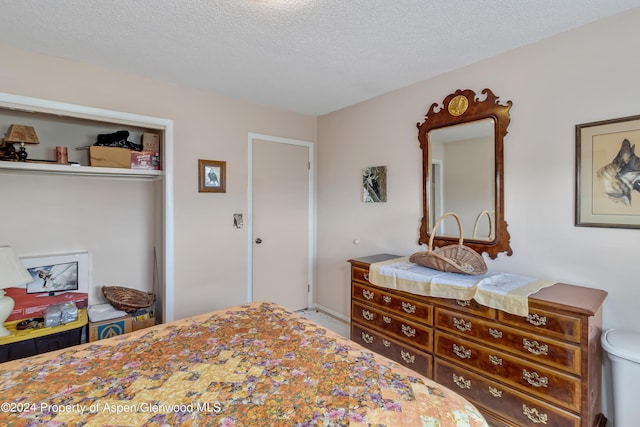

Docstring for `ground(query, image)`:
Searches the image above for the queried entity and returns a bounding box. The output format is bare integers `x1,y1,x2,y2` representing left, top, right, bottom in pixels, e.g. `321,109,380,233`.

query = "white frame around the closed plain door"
246,132,315,308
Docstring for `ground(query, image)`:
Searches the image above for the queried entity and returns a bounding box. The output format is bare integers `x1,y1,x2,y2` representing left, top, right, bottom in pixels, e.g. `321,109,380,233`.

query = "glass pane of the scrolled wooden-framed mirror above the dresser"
428,118,496,241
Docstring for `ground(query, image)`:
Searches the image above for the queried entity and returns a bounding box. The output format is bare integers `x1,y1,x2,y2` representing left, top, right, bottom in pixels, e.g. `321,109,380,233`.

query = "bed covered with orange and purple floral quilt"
0,303,487,427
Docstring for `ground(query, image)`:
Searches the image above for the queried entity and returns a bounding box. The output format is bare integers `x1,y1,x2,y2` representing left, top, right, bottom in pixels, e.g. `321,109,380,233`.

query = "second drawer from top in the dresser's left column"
351,282,433,325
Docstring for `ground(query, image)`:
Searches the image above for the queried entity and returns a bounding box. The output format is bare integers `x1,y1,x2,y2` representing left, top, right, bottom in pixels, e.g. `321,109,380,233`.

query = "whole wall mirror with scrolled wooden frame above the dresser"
417,89,513,258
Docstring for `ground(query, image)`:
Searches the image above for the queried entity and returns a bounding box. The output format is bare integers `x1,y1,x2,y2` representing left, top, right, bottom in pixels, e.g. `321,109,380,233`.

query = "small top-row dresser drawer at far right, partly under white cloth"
498,307,581,343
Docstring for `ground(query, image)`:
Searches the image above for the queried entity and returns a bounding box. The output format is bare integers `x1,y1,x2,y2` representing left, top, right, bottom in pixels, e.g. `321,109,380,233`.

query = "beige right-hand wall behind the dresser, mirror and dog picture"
316,5,640,331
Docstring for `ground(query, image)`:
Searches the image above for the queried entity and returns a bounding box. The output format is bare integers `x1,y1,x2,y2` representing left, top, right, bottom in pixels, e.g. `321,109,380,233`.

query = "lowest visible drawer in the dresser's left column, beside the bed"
351,323,433,378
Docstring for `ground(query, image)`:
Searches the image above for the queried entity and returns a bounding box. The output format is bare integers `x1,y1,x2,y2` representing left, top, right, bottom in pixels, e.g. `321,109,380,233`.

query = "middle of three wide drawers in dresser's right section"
433,332,581,411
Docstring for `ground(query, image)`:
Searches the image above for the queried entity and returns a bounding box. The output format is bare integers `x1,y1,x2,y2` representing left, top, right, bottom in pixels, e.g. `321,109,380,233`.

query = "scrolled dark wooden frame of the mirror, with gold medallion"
416,88,513,259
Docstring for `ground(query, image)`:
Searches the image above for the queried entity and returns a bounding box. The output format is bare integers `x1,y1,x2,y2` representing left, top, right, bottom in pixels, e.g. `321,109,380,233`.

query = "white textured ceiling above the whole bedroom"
0,0,640,115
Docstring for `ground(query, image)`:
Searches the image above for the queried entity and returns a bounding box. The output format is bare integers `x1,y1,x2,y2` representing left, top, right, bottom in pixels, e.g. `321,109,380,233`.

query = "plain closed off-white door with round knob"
249,135,312,310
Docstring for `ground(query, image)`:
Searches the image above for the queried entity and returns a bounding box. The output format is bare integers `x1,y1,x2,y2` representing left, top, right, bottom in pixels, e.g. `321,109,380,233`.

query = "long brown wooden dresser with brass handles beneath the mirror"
349,254,607,427
